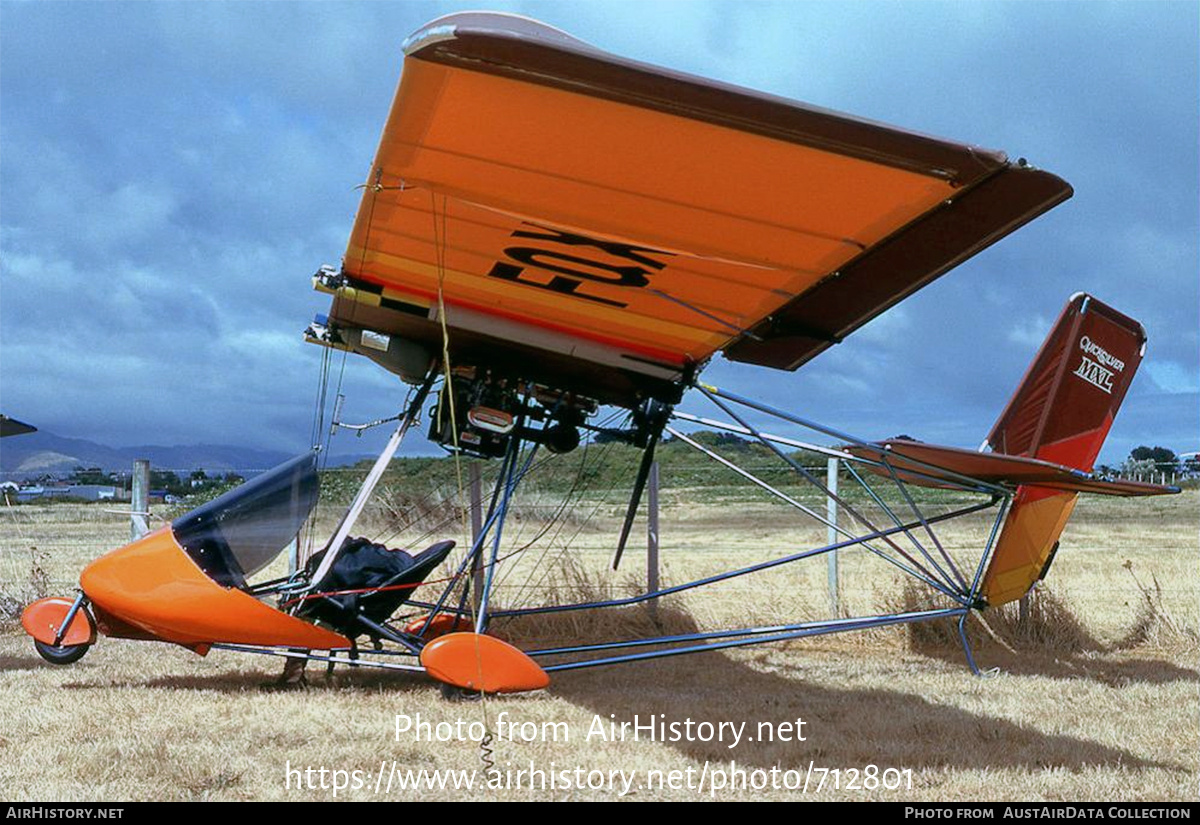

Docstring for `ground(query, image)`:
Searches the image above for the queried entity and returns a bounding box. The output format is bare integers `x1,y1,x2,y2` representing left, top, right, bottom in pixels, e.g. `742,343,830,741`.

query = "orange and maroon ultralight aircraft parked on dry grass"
23,13,1176,693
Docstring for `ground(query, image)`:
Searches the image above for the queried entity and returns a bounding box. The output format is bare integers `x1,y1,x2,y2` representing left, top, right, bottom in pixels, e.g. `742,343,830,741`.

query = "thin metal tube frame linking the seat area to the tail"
225,374,1012,674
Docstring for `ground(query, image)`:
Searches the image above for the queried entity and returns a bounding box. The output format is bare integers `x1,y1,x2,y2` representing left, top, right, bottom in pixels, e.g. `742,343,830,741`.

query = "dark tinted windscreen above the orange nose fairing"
172,452,319,588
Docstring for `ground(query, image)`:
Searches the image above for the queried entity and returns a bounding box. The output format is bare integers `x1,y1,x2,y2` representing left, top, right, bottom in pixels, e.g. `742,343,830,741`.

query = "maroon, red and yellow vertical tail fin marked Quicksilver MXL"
980,293,1146,604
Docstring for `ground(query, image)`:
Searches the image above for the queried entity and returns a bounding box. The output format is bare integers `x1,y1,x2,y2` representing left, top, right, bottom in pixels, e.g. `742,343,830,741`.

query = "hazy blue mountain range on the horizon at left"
0,430,354,481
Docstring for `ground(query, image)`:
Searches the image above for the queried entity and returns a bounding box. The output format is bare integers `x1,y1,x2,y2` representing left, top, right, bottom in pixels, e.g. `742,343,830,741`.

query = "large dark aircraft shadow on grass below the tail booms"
552,652,1183,772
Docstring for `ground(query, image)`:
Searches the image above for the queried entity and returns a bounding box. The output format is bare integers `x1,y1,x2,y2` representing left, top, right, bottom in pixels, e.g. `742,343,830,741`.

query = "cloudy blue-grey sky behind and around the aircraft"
0,0,1200,462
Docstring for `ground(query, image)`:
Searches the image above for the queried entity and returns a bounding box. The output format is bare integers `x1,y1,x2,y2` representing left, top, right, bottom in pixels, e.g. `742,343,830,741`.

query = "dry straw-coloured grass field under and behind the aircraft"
0,488,1200,801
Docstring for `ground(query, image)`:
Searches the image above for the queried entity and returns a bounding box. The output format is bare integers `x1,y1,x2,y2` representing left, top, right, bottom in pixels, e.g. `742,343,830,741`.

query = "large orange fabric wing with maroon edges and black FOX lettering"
332,13,1070,403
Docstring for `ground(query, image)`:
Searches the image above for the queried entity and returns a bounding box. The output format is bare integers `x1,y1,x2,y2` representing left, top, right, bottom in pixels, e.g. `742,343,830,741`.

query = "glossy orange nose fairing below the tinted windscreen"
79,526,350,650
